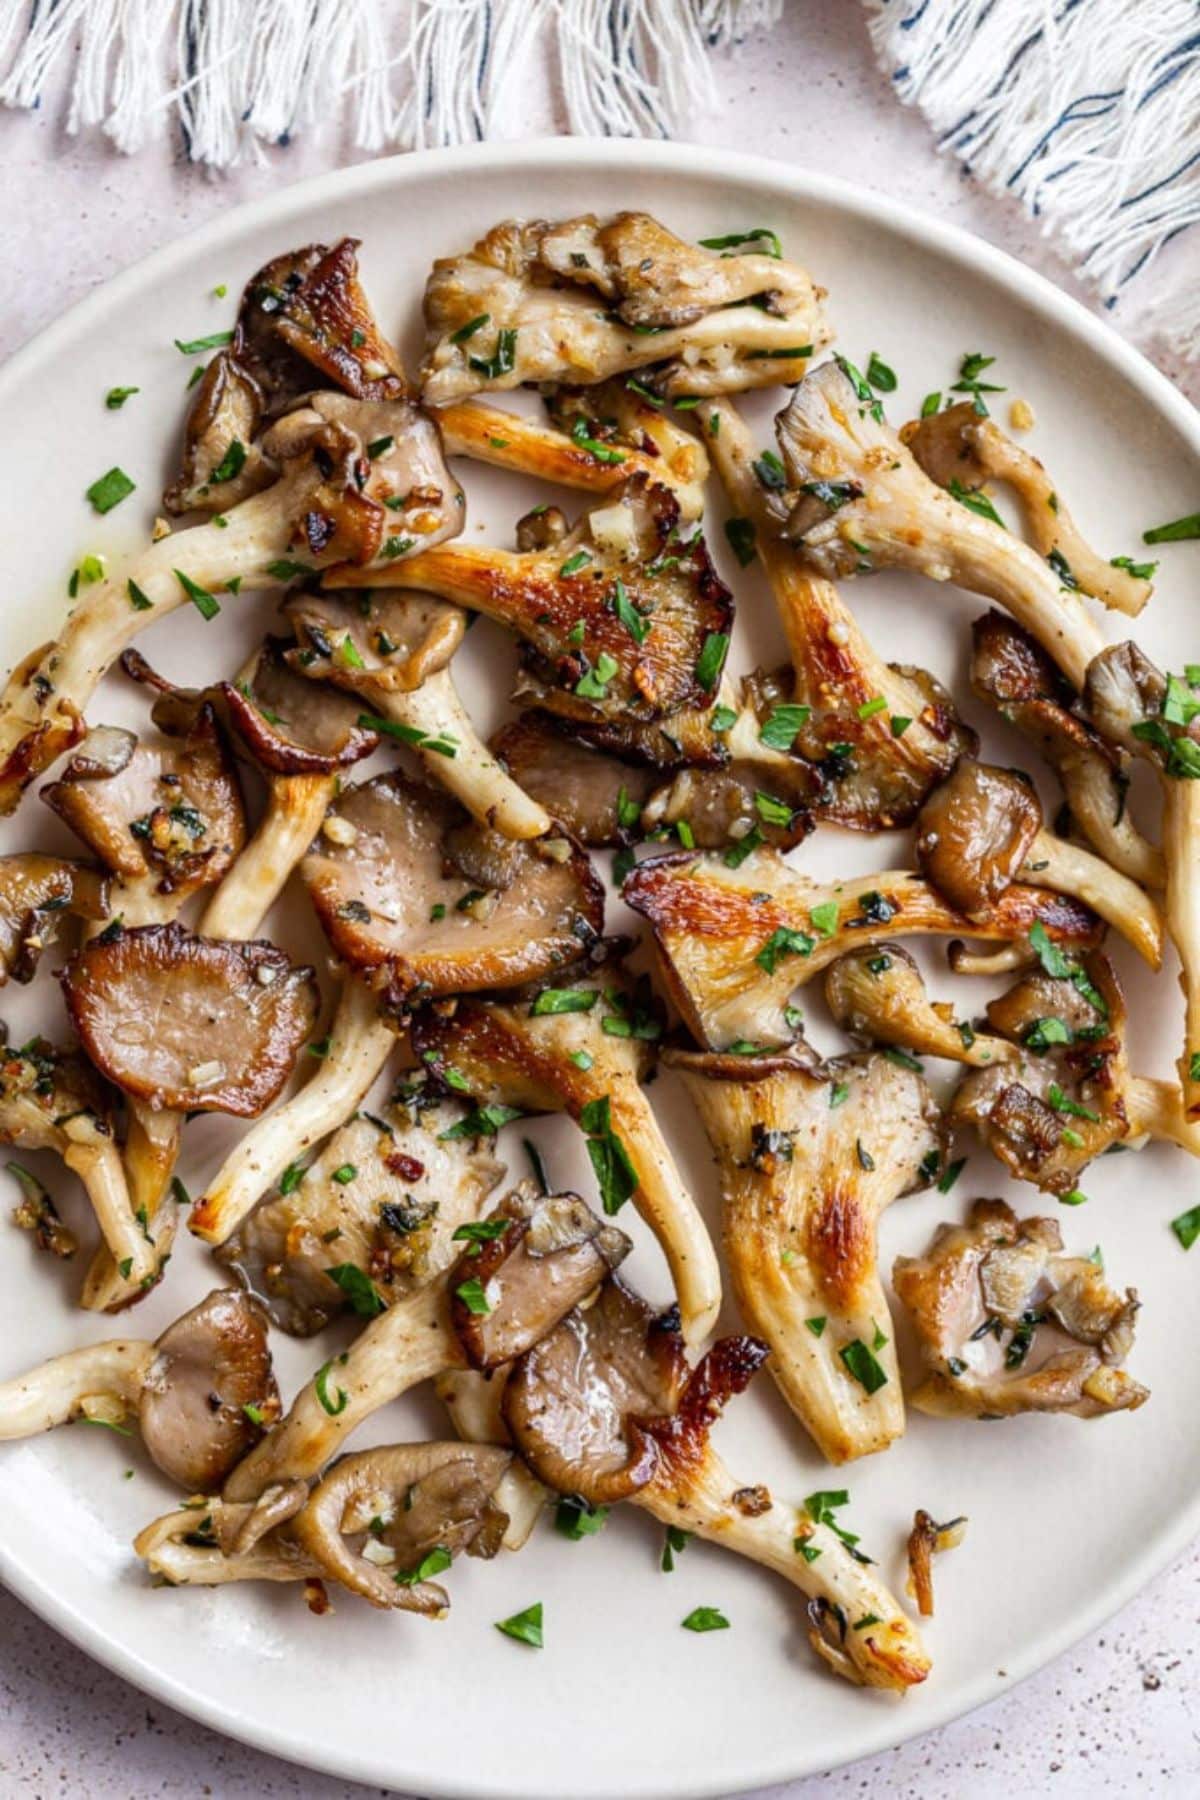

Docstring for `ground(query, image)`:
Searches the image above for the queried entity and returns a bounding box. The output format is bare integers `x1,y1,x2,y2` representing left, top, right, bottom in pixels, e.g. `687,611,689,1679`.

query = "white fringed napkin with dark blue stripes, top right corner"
867,0,1200,356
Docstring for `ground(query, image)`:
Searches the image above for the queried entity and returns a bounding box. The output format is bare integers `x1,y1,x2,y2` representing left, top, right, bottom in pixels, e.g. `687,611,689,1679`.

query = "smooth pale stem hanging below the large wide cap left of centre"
189,977,396,1244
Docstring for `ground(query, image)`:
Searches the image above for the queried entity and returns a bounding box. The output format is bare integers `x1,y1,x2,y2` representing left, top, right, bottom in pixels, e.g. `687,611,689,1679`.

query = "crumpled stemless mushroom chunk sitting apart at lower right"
892,1201,1150,1418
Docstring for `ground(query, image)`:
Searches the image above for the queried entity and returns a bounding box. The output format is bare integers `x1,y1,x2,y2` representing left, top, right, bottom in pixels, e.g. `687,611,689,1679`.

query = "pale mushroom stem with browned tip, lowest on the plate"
630,1449,930,1692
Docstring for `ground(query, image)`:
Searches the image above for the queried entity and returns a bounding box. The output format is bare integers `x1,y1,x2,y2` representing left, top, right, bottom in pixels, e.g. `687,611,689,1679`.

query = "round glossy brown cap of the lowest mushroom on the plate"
504,1280,687,1507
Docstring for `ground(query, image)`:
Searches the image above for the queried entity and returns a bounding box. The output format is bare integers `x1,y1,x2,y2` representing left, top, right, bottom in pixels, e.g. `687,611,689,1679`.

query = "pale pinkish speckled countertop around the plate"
0,0,1200,1800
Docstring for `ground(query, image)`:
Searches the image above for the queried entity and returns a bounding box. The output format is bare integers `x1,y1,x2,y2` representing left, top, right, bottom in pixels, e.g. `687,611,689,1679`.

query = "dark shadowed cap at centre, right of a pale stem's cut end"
491,713,657,848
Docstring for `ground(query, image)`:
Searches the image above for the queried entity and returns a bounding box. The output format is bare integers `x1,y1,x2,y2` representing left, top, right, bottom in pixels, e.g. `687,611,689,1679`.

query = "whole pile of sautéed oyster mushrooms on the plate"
0,212,1200,1690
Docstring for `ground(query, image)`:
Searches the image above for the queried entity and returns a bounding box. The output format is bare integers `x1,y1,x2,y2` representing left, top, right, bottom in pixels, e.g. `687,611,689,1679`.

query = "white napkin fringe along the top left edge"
0,0,783,167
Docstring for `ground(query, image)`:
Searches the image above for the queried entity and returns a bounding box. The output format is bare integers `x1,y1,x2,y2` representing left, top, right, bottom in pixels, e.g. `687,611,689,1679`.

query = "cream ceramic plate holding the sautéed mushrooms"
0,140,1200,1800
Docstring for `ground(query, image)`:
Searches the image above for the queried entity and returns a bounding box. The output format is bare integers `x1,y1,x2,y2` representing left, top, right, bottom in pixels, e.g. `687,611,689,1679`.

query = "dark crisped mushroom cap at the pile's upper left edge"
164,238,405,513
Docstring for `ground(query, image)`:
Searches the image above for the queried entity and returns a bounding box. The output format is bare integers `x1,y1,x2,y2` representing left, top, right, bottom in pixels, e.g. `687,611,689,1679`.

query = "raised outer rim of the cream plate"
0,137,1200,1800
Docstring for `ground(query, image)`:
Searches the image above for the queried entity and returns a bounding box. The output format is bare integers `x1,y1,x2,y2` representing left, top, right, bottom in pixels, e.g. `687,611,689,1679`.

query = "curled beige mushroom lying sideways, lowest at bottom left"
133,1444,513,1618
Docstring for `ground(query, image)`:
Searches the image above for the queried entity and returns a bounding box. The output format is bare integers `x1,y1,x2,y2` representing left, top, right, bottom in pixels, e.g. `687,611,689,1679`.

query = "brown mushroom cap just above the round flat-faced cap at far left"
41,704,246,895
